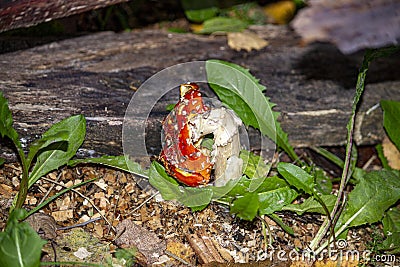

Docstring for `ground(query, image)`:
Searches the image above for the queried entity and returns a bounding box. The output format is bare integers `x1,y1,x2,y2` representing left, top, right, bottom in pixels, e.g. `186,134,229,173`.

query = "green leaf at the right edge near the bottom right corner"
379,207,400,254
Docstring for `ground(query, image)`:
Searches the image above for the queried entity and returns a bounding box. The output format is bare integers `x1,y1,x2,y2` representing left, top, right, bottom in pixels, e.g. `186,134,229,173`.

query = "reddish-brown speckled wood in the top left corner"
0,0,128,32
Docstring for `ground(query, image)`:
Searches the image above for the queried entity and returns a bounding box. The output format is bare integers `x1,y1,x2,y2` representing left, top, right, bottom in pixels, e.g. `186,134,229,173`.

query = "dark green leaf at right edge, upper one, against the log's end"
381,100,400,150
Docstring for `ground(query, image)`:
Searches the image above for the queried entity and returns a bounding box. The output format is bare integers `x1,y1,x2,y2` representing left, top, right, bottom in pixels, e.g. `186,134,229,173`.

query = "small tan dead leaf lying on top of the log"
227,31,268,52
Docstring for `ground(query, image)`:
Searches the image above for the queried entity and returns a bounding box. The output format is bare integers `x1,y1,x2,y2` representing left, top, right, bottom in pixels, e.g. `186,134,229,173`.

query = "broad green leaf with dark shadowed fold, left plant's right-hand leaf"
28,115,86,187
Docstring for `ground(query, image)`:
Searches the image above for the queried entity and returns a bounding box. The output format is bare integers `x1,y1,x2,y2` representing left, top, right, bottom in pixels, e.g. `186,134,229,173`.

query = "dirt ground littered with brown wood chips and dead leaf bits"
0,148,388,266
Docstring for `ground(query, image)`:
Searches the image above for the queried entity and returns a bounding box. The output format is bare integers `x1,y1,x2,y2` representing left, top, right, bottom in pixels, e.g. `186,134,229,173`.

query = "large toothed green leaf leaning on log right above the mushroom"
206,60,298,160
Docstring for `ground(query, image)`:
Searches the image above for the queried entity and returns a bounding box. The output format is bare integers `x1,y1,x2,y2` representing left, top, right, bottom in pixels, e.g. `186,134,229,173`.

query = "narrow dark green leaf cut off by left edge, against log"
0,91,25,161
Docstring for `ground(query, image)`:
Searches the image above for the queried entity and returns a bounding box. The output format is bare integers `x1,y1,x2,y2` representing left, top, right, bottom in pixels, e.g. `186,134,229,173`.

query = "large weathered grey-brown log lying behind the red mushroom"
0,26,400,161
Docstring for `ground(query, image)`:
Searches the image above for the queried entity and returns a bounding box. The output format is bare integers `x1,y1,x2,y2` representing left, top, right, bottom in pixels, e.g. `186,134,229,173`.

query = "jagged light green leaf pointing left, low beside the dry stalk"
282,195,337,215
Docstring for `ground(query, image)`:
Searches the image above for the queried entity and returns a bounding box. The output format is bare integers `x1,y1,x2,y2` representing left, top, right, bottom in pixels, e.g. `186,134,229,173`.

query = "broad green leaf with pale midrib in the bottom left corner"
0,209,46,267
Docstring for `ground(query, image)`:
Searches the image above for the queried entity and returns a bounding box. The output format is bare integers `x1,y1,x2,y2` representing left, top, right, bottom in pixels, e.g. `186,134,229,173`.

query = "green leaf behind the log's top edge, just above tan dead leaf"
195,17,249,34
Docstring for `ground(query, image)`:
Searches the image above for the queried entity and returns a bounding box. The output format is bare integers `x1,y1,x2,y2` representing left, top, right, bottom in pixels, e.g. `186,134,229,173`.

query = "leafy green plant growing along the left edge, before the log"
0,92,120,266
